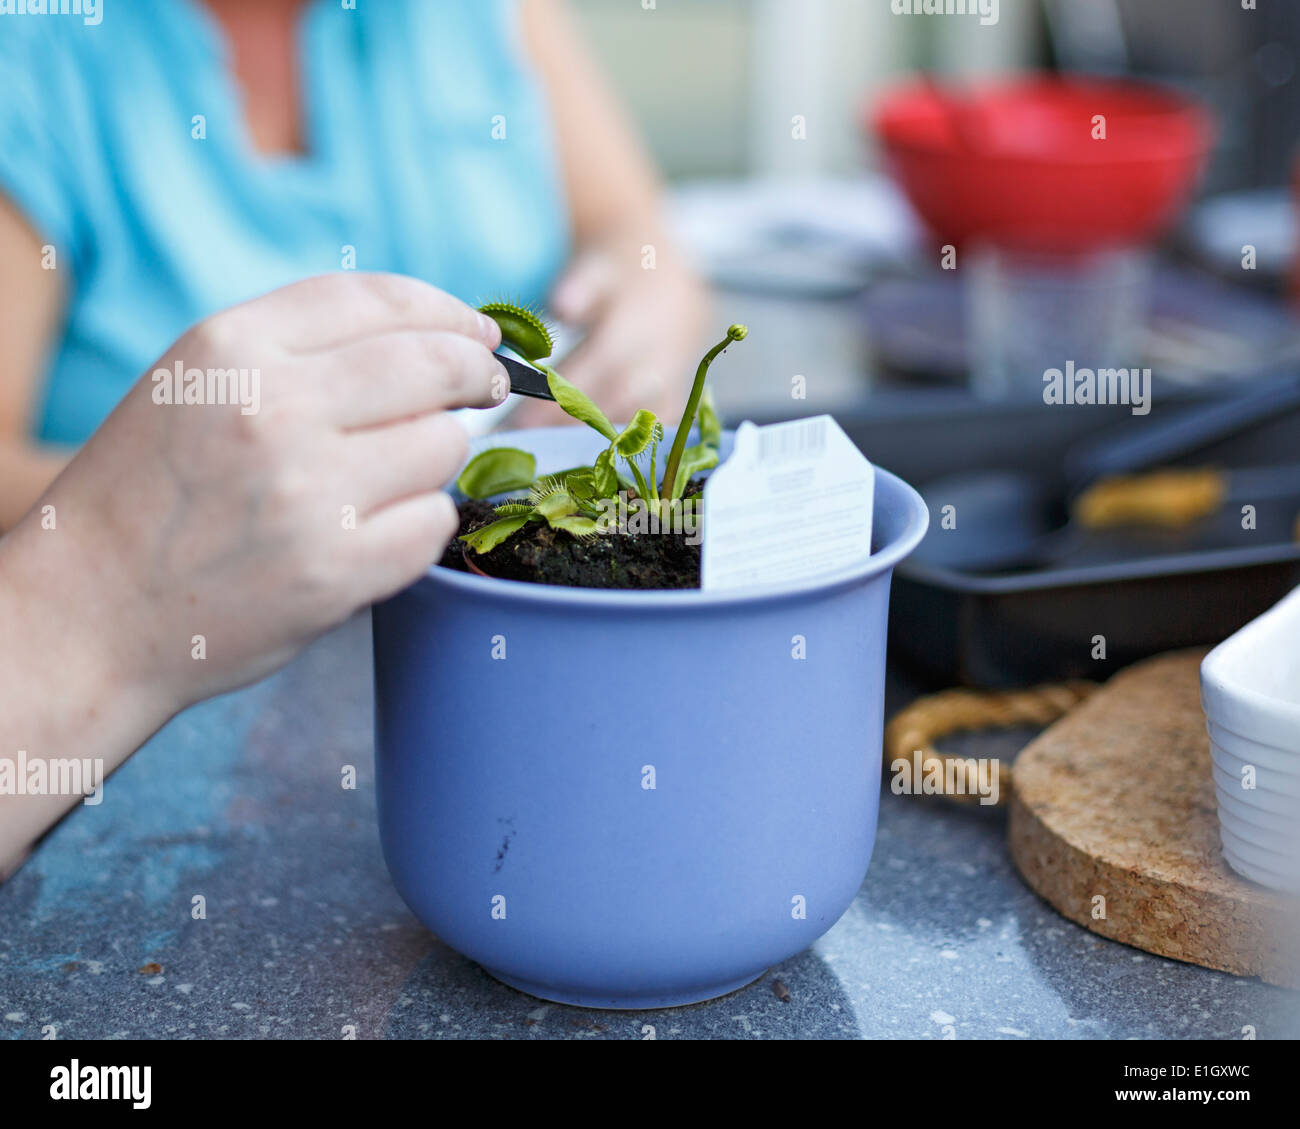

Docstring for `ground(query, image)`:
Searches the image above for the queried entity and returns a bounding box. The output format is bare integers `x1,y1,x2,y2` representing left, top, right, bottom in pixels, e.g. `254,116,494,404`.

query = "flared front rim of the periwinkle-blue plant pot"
416,428,930,611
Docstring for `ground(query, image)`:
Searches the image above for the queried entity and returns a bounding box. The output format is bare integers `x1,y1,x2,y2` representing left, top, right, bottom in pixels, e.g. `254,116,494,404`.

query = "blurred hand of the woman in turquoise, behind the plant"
517,241,709,427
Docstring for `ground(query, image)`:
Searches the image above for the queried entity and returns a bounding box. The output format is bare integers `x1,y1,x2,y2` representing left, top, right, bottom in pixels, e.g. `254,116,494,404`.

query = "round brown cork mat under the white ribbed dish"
1009,650,1300,986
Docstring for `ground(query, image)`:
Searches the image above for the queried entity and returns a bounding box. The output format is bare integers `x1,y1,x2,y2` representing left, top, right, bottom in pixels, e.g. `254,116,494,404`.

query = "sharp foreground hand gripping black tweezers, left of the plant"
0,274,506,714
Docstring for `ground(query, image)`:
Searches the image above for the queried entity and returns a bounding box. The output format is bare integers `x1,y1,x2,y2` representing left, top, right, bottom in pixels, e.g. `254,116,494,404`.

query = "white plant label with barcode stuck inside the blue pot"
701,415,875,591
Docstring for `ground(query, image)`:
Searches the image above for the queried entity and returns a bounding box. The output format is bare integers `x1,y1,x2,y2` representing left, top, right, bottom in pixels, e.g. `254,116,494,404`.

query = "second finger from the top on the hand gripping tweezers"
318,332,510,429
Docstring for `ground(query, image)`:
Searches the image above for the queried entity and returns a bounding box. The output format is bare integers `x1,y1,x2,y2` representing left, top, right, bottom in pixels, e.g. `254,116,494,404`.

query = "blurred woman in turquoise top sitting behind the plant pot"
0,0,702,529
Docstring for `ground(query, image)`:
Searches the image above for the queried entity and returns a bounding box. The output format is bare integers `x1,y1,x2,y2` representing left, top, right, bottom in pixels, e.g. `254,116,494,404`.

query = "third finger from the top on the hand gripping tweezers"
342,412,469,520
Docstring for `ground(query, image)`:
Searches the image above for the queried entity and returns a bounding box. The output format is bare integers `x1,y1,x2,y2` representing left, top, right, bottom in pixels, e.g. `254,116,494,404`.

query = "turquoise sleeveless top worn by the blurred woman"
0,0,569,444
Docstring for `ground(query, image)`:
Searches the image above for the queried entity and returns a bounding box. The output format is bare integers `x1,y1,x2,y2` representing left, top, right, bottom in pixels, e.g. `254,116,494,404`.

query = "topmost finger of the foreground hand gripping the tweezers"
220,272,501,352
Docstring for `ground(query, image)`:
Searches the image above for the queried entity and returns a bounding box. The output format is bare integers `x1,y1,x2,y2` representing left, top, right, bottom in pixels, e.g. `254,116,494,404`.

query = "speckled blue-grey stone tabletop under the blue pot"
0,617,1300,1039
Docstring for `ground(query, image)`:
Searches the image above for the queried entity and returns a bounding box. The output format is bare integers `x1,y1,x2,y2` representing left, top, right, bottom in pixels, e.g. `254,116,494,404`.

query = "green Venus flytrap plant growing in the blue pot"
456,300,748,554
